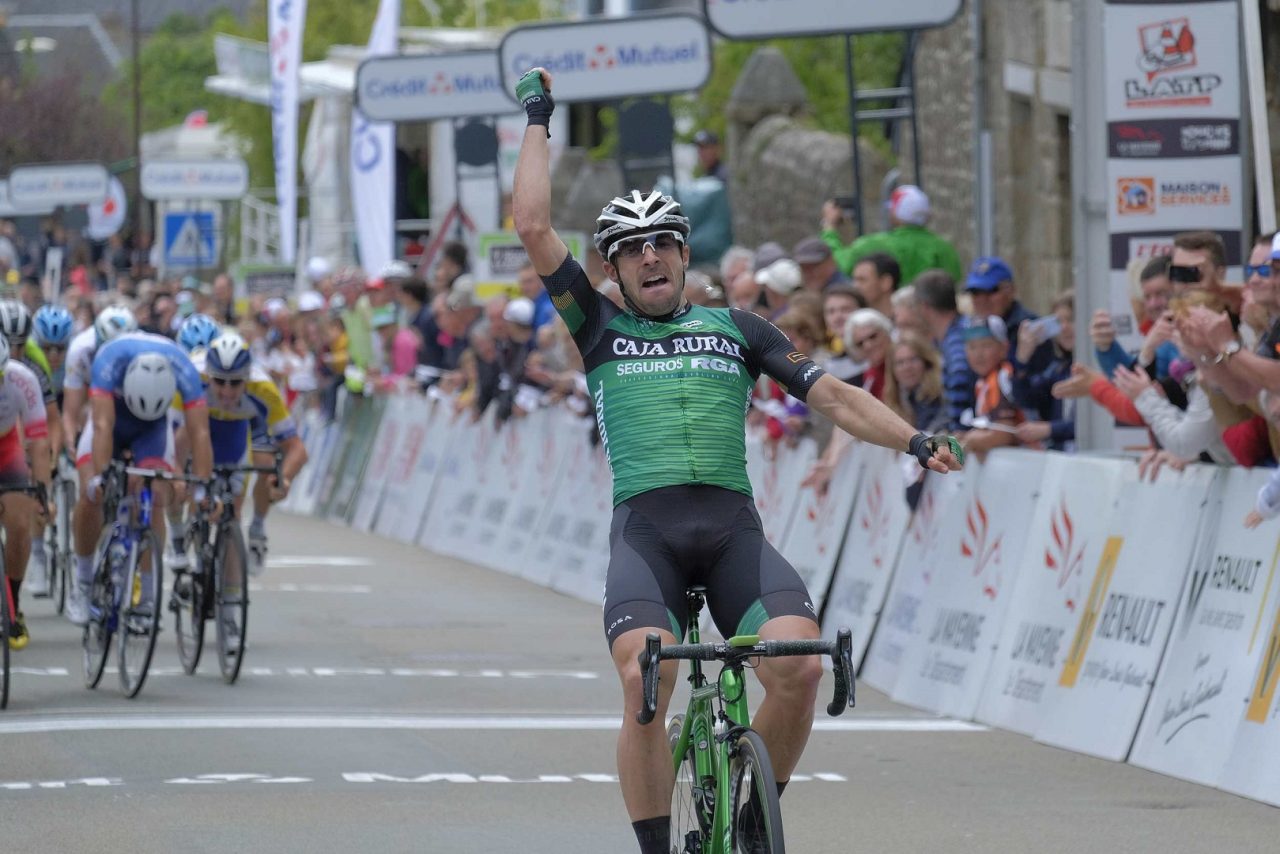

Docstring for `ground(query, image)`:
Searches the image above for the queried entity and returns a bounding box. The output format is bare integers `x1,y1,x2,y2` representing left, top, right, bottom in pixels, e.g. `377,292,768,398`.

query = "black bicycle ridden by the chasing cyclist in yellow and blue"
169,452,283,685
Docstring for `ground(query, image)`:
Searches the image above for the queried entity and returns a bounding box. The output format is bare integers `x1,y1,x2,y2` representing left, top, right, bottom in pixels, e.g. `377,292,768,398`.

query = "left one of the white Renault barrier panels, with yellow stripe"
1036,466,1219,762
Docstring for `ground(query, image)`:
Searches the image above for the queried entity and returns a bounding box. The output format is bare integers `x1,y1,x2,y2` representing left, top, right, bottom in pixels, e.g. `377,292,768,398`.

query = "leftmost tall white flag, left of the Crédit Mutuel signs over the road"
266,0,307,264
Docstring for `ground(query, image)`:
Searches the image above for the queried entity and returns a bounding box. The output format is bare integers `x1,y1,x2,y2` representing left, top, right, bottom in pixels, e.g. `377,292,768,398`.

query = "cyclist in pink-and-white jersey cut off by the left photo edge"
0,335,51,649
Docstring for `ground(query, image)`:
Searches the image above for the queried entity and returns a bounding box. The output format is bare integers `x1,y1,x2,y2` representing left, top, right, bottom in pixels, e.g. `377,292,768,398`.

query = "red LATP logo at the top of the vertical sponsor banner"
1124,18,1222,108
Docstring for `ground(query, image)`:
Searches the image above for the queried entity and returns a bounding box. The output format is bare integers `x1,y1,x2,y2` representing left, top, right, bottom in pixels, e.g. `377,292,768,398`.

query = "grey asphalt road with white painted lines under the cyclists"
0,516,1280,854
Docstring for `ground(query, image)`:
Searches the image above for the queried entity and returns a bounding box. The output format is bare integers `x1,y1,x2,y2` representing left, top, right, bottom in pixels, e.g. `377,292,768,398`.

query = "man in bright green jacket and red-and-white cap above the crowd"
822,184,963,284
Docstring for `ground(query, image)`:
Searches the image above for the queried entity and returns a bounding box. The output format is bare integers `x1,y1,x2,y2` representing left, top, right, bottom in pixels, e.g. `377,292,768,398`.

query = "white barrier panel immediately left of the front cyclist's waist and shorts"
543,440,612,602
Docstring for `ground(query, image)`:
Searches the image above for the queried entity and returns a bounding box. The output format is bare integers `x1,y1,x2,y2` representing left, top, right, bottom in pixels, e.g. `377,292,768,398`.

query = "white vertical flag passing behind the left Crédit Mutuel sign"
351,0,401,275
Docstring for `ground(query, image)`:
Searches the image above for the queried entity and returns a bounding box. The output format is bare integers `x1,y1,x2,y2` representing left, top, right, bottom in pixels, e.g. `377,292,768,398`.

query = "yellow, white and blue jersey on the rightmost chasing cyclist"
191,351,298,465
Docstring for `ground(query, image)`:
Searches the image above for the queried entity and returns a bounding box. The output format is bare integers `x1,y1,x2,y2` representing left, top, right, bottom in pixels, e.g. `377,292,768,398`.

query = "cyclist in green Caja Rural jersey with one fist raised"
515,68,960,854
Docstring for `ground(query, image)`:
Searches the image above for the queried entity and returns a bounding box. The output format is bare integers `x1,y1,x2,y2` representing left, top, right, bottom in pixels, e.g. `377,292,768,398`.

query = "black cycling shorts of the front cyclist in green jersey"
604,485,818,648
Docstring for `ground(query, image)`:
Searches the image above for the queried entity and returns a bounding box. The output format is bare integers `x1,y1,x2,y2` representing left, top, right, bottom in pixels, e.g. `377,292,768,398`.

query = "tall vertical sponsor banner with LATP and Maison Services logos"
1105,0,1244,346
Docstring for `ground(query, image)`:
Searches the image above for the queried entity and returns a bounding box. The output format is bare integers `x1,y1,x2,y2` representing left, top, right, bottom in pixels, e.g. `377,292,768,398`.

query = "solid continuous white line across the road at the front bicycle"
0,714,988,735
